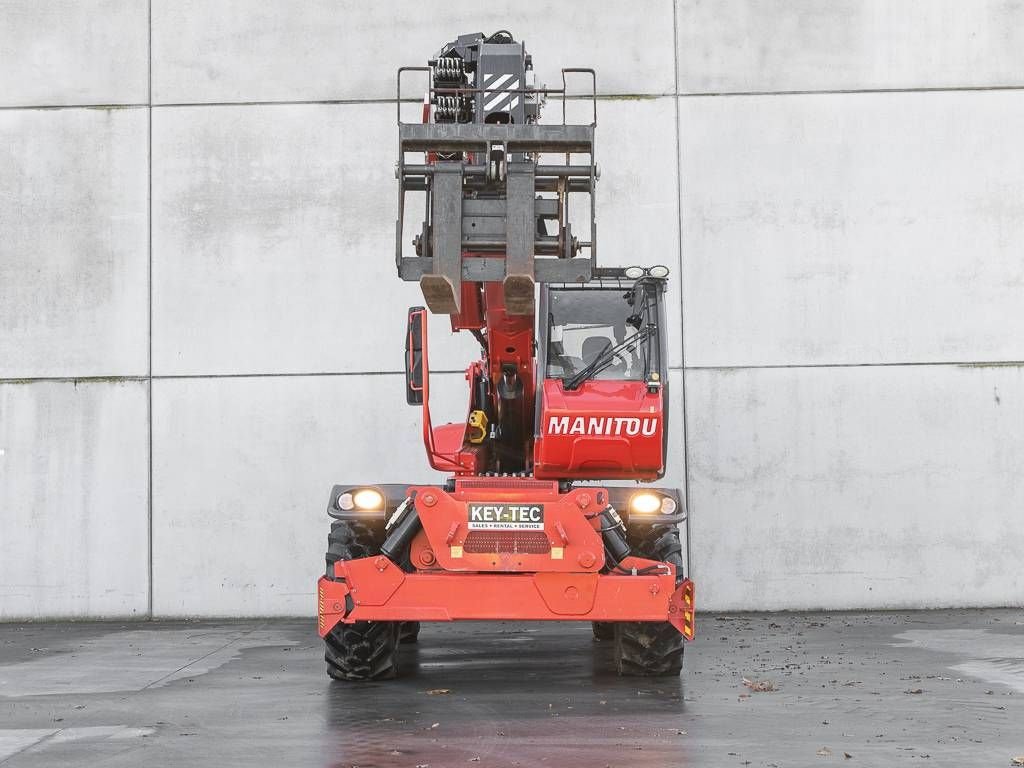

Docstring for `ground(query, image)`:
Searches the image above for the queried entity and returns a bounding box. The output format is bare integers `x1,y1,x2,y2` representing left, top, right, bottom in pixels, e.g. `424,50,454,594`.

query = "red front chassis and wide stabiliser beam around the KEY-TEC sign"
317,478,694,639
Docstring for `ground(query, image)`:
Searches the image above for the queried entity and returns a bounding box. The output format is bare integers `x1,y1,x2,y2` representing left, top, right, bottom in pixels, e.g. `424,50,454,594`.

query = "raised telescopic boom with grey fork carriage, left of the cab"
395,32,597,473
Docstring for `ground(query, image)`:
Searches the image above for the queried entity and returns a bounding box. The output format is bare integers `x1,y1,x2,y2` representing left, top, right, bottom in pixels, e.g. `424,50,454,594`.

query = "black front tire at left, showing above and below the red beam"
324,520,401,680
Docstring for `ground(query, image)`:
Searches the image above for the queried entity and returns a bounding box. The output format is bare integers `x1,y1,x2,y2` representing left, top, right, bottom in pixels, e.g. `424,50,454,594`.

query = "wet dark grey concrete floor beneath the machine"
0,610,1024,768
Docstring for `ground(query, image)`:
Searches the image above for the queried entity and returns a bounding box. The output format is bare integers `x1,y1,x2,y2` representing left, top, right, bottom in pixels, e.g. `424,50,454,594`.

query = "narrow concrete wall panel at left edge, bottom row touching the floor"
0,381,148,620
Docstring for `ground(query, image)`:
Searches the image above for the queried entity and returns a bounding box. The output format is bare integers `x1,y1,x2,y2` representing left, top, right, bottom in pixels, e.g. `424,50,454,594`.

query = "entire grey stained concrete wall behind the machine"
0,0,1024,618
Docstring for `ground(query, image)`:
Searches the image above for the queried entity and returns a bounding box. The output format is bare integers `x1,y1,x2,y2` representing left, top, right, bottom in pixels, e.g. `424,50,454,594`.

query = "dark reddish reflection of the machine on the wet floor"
324,624,688,768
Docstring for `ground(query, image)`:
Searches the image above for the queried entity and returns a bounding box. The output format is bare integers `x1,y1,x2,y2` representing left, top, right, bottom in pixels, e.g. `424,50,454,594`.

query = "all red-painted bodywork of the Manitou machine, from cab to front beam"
318,280,693,638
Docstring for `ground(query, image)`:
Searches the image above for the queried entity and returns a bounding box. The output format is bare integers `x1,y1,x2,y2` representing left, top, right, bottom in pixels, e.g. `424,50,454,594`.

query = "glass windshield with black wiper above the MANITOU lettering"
546,281,660,389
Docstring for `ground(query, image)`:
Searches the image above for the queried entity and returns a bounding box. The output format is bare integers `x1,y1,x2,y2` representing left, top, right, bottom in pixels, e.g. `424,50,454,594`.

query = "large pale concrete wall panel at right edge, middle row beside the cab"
680,91,1024,366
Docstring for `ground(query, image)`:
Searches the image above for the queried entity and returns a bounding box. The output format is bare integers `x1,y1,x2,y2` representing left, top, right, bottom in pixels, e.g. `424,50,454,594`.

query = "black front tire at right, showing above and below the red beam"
614,525,684,677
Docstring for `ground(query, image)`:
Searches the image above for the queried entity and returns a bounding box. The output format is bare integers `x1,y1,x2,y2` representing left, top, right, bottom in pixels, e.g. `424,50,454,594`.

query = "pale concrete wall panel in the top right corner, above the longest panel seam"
677,0,1024,93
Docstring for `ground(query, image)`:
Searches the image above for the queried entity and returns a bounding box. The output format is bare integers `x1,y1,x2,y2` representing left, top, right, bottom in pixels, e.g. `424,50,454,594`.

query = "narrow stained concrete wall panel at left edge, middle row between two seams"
0,109,148,378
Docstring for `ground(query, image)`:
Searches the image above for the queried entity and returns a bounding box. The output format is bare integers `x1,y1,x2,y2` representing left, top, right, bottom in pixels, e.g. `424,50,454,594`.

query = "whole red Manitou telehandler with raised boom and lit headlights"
317,31,694,680
